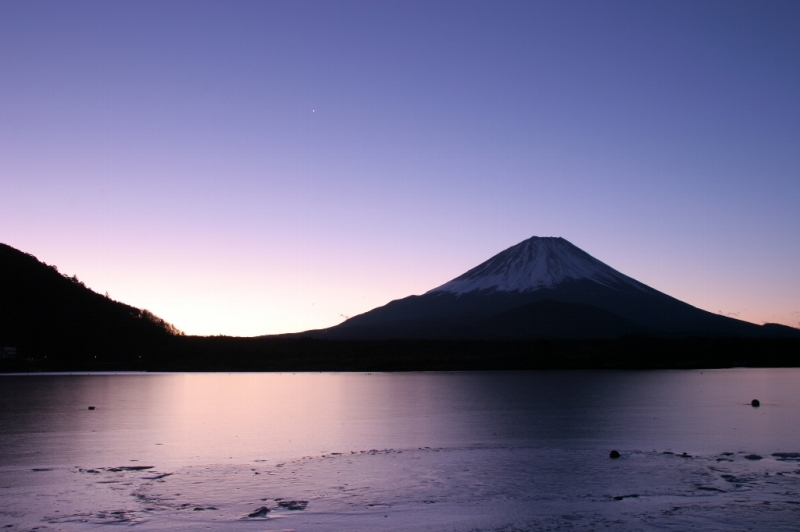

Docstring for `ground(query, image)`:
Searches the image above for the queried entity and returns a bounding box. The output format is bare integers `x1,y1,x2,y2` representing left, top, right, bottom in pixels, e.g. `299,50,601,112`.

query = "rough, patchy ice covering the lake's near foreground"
0,447,800,532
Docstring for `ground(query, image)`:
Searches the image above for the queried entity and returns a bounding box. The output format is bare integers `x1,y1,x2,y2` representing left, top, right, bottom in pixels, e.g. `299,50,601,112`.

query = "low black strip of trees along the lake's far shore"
6,336,800,372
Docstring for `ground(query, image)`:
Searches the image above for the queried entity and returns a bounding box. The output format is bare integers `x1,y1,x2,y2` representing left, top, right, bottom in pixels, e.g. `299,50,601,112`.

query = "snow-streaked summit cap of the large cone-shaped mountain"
428,236,646,295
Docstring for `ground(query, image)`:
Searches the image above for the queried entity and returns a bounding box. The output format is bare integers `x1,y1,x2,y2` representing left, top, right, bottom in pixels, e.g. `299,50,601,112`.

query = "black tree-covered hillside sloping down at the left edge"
0,244,179,368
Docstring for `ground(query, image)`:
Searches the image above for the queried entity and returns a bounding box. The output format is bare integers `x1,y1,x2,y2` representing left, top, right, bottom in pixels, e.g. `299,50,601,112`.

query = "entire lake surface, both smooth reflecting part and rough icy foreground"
0,369,800,532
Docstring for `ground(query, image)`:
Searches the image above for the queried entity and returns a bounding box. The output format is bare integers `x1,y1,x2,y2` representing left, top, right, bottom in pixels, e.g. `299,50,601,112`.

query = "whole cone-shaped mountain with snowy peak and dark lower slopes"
314,237,800,340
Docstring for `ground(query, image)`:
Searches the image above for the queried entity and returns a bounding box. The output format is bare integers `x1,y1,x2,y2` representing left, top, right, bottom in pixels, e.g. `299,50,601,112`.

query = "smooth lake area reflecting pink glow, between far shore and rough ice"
0,369,800,467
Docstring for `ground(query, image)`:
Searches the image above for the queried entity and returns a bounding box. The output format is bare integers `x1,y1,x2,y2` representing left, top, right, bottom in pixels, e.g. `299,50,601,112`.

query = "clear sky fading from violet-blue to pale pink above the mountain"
0,0,800,336
